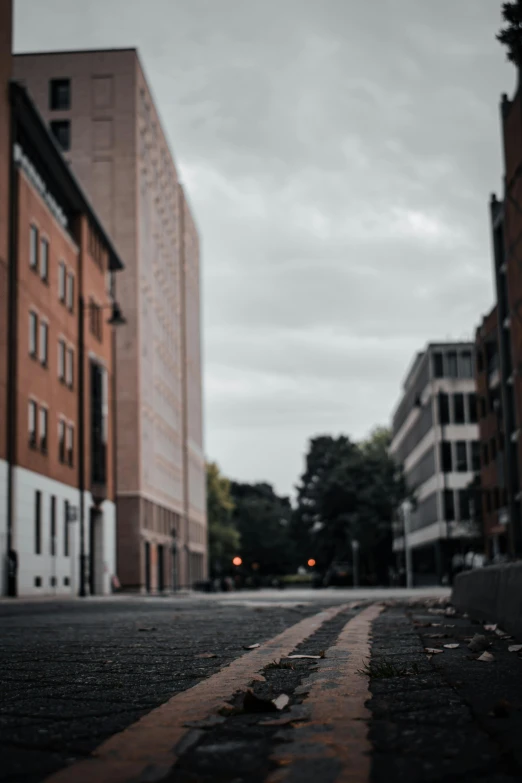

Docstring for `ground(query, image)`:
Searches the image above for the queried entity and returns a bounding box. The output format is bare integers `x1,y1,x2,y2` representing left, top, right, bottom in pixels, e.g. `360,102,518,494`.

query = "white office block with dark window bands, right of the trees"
390,343,480,584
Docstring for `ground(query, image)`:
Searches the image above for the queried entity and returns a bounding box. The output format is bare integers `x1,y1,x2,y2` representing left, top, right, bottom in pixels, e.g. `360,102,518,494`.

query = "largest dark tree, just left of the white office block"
292,428,406,582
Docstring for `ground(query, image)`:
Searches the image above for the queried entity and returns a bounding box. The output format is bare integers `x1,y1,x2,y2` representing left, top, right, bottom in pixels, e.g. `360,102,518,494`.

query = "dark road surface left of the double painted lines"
0,589,456,783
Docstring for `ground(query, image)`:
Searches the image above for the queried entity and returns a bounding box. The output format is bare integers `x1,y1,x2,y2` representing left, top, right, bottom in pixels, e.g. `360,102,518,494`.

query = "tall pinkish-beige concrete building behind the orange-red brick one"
13,49,207,592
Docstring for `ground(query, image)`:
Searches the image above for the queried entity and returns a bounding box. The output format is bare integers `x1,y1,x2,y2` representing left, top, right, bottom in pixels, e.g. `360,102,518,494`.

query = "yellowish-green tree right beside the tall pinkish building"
206,462,241,576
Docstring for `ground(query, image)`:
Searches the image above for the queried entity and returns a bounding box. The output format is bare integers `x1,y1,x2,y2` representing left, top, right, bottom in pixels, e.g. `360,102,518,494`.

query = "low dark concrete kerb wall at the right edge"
451,563,522,638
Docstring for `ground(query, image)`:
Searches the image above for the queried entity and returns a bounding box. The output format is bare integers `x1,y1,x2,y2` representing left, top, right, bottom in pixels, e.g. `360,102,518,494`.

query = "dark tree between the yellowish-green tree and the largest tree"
231,481,294,577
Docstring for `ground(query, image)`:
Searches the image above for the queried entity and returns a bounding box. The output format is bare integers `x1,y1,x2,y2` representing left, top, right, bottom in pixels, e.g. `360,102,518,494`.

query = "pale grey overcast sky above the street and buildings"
15,0,515,493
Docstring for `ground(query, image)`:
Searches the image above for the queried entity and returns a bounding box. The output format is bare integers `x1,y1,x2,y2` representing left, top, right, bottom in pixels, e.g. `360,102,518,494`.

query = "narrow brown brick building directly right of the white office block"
475,306,508,560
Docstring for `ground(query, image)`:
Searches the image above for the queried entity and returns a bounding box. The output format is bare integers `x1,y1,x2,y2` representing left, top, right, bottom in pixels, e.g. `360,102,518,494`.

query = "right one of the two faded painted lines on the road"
267,604,383,783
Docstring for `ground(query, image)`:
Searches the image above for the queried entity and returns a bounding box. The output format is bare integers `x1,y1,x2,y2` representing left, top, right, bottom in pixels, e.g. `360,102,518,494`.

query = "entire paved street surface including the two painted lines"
0,590,522,783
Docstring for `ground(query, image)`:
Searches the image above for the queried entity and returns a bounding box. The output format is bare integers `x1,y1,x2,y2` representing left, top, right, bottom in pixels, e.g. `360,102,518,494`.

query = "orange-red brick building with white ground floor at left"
0,2,123,595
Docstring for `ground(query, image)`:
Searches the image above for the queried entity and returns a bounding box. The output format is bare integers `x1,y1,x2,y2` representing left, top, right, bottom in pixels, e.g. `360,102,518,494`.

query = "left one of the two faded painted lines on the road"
44,602,358,783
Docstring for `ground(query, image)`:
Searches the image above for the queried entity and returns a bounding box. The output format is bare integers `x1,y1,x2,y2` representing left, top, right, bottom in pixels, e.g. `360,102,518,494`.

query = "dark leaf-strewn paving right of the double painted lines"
368,604,522,783
